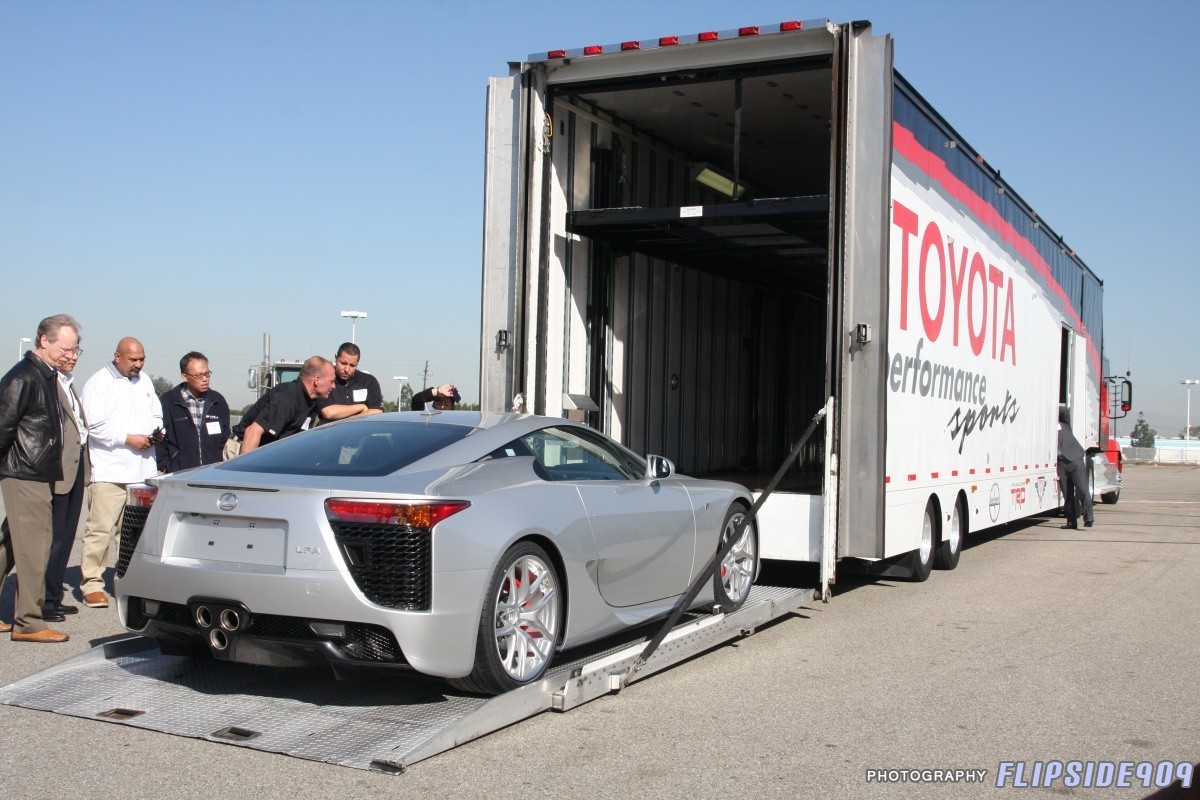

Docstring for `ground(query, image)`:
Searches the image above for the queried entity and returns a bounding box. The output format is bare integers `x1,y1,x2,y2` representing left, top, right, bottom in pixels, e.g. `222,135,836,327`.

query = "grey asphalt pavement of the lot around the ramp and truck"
0,465,1200,800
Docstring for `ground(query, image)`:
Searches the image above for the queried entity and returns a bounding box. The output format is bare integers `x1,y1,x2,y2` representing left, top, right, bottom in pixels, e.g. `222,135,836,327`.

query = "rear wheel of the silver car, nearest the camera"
450,542,566,694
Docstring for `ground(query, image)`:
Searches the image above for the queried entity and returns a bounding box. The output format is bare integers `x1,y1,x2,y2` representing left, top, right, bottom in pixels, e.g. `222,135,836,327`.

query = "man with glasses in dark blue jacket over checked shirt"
156,350,229,473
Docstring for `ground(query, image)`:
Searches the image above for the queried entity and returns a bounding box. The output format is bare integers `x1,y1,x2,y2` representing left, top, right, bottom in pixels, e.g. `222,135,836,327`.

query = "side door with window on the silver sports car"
524,427,696,607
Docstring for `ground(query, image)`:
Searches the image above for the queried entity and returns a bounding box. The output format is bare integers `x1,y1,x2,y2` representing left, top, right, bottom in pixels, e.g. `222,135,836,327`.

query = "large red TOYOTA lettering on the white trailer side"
892,200,1016,366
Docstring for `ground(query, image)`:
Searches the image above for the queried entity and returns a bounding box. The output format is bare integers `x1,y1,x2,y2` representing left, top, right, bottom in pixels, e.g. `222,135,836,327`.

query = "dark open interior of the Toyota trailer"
547,55,839,493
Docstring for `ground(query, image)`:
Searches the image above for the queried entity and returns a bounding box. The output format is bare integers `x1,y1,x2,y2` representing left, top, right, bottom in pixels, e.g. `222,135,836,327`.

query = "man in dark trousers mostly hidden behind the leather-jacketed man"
42,348,91,622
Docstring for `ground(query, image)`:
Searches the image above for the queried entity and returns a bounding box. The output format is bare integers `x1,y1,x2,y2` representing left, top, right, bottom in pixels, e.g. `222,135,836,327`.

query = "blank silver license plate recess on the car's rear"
167,513,287,567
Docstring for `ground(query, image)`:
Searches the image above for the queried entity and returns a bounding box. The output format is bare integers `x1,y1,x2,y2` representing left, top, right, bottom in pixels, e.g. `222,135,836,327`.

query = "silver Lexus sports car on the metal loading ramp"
116,411,758,693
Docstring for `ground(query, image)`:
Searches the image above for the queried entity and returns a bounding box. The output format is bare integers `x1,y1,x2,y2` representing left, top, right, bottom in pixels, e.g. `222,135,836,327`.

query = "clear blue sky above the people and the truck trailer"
0,0,1200,435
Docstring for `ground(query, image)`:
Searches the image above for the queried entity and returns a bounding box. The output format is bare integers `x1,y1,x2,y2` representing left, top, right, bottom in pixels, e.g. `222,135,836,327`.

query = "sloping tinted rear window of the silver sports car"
217,421,474,476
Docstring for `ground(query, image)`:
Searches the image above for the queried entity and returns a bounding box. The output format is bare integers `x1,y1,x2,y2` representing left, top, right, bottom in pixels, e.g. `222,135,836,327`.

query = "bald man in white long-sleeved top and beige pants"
79,337,162,608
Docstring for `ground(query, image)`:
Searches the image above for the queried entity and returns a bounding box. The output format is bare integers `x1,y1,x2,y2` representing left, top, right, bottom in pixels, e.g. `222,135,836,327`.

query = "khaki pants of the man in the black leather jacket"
0,477,54,633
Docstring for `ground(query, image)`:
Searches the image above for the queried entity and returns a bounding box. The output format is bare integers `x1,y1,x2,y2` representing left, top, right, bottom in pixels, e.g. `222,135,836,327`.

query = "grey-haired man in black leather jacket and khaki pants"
0,314,79,642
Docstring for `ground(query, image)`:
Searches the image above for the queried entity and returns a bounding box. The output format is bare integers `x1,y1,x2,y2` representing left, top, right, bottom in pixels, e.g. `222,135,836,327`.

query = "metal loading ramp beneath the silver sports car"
0,587,814,772
